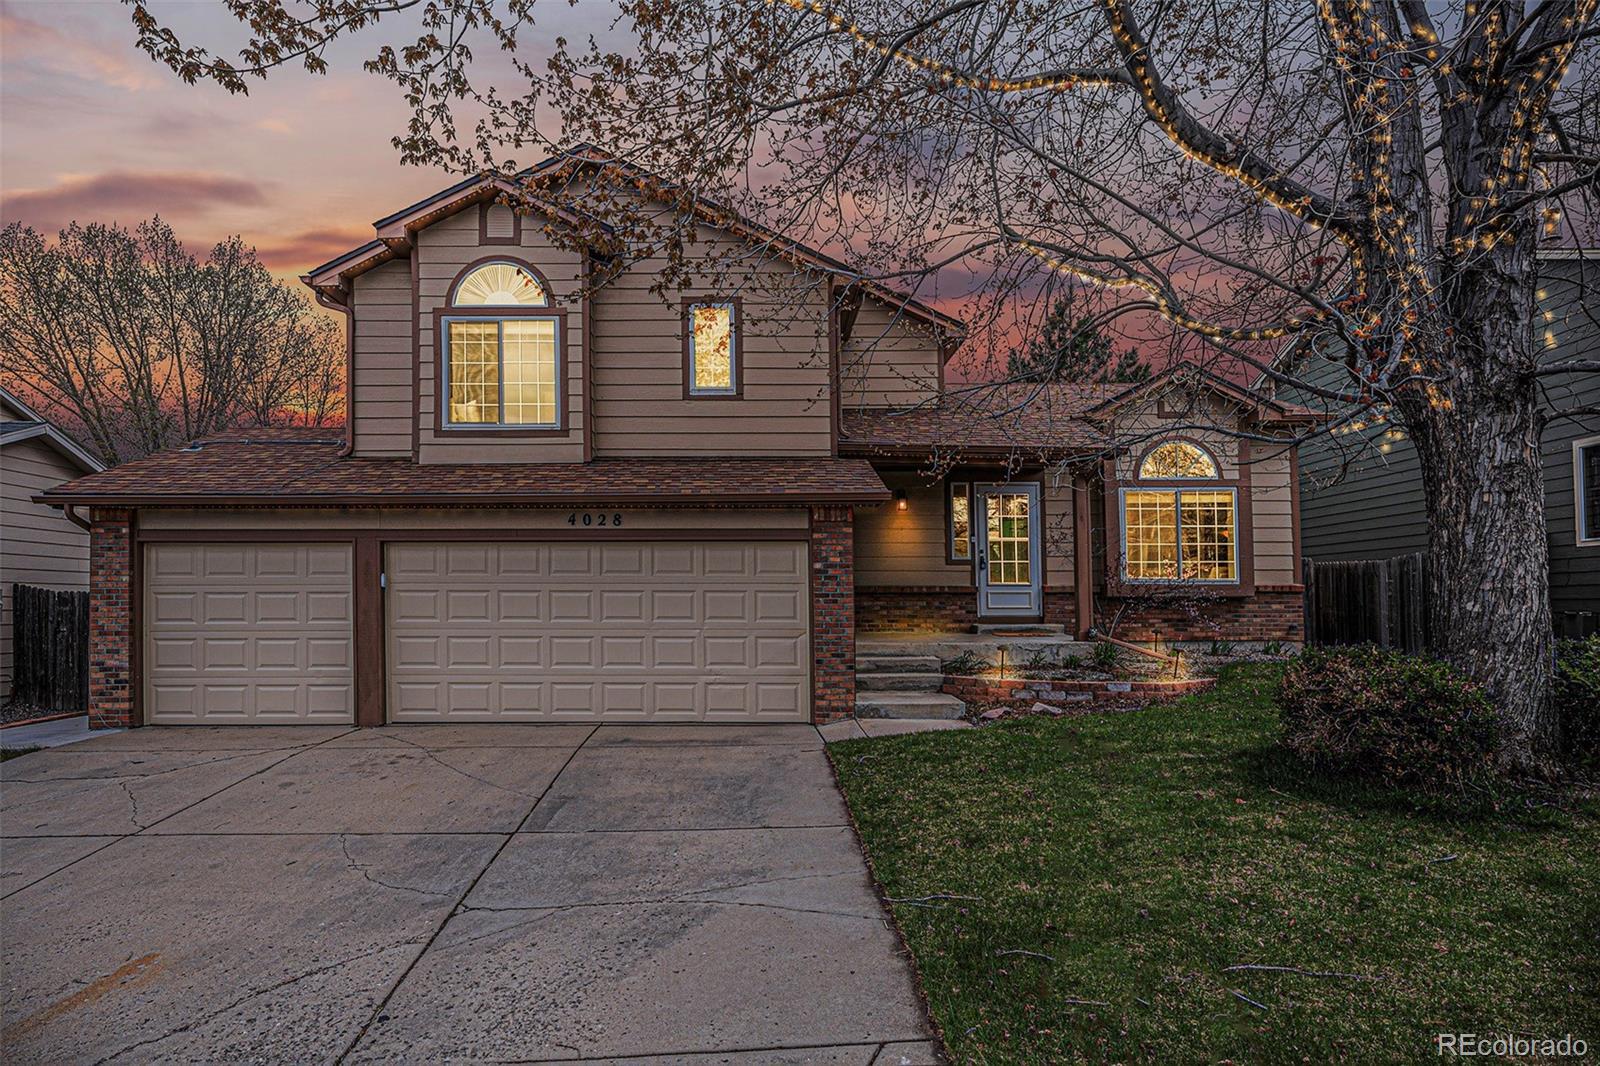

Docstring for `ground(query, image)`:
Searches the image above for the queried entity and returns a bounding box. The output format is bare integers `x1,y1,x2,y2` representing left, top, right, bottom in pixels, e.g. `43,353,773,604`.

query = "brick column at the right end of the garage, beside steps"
811,507,856,725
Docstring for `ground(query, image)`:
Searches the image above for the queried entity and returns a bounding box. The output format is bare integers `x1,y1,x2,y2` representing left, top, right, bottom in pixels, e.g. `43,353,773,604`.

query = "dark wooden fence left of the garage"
11,584,90,712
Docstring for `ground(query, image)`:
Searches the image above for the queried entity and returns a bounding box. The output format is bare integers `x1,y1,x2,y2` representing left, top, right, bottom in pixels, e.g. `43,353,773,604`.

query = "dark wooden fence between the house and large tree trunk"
1301,552,1427,653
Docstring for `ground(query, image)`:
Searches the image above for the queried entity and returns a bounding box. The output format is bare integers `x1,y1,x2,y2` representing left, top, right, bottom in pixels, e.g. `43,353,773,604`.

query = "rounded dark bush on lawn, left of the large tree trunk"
1278,647,1502,795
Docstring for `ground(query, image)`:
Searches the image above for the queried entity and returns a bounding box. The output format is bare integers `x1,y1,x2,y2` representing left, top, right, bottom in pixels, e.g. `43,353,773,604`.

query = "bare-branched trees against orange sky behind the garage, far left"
0,218,344,463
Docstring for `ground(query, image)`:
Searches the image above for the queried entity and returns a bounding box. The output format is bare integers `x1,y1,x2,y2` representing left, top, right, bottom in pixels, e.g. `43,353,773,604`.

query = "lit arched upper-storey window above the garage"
440,259,565,431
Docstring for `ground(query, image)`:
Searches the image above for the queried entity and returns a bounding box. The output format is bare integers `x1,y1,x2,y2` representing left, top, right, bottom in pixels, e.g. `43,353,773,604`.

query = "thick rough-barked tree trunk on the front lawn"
1403,251,1558,758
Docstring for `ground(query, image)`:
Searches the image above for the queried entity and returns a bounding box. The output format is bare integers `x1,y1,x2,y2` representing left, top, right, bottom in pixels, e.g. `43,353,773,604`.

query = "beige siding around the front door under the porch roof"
856,471,1074,589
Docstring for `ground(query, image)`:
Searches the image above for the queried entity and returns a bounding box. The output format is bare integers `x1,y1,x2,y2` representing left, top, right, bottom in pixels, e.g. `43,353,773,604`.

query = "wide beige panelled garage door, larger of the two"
386,541,811,722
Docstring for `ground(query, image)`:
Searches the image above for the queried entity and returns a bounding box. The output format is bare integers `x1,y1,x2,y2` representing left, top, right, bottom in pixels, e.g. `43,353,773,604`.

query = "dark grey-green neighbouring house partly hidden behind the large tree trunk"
1283,250,1600,632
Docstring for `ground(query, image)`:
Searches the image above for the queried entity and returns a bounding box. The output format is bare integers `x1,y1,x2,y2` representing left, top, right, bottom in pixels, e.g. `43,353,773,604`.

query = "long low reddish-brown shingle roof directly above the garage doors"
40,429,890,506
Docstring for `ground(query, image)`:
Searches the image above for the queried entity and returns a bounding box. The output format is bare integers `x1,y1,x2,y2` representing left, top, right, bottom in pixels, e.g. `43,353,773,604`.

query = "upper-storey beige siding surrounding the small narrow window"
592,222,832,456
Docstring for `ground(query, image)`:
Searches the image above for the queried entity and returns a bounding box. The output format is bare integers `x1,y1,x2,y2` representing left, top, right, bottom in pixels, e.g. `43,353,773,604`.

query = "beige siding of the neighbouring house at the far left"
0,437,90,699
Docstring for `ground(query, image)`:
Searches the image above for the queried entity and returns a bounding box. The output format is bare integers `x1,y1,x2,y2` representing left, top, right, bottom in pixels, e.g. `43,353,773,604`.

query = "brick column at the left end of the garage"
90,509,134,730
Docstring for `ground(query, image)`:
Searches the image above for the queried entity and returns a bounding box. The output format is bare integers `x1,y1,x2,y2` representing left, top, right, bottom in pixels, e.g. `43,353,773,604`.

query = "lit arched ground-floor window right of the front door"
1122,440,1238,583
